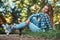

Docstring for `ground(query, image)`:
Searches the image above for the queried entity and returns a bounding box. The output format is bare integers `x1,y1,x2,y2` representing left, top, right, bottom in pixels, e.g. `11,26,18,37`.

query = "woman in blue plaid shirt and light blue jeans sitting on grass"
3,6,52,34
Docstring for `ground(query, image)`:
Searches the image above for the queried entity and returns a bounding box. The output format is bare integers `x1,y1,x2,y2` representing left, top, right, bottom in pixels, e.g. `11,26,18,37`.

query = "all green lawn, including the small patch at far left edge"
0,28,60,39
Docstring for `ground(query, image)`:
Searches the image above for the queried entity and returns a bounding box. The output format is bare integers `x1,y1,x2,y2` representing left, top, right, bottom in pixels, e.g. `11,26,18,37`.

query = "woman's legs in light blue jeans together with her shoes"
4,22,41,35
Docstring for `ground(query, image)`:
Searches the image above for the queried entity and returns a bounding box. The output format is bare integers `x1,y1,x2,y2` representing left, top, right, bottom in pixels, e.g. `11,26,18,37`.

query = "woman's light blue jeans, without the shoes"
12,22,40,32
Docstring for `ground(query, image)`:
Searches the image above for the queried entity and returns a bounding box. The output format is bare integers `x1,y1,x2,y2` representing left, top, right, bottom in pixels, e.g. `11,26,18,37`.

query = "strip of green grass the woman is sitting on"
23,30,60,39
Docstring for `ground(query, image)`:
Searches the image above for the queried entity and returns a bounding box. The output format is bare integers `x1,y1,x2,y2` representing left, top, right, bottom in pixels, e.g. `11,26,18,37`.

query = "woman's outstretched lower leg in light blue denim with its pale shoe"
3,22,27,35
